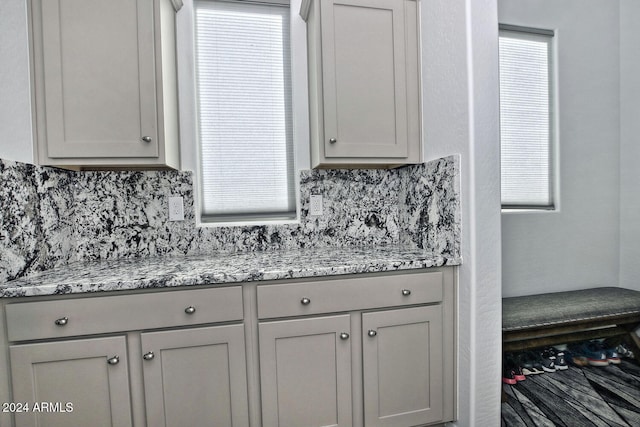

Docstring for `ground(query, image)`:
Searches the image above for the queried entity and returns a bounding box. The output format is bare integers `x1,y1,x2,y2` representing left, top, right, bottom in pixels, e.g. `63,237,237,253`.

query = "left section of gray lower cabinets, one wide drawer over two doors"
0,286,249,427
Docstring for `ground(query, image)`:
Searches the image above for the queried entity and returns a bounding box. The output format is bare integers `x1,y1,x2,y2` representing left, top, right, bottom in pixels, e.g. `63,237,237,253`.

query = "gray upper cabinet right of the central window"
301,0,422,167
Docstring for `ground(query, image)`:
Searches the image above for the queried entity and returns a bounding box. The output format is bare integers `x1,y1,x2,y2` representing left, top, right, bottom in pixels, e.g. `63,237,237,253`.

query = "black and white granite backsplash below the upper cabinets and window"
0,156,461,283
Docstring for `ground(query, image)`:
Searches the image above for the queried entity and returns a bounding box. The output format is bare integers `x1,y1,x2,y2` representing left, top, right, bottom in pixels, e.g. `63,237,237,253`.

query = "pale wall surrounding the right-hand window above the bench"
499,0,620,297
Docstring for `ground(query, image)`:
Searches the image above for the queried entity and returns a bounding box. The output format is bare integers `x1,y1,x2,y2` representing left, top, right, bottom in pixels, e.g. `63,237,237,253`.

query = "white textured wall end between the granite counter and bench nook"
421,0,501,427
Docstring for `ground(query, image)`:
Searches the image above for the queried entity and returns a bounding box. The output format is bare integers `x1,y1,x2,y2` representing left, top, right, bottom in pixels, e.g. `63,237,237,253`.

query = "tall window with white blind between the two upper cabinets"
195,0,296,221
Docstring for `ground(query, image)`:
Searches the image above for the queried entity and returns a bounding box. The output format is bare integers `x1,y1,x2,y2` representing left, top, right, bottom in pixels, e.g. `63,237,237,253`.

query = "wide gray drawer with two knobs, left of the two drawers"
6,286,243,341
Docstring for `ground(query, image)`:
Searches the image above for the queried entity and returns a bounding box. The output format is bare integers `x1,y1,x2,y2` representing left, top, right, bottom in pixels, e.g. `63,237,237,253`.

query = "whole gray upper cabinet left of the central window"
29,0,182,168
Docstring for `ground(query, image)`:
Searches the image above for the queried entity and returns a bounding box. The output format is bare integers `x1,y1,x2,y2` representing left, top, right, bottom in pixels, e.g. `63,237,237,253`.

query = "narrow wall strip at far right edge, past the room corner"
620,0,640,290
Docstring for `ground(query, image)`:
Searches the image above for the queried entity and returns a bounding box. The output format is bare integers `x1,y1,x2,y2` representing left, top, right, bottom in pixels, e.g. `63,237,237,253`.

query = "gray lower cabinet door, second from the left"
141,325,249,427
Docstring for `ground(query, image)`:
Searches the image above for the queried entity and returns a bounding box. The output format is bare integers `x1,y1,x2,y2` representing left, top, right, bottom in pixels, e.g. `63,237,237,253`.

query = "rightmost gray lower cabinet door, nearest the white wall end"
362,305,442,427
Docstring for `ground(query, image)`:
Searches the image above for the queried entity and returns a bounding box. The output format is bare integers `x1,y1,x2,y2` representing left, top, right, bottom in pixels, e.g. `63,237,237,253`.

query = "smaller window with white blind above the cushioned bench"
499,25,554,209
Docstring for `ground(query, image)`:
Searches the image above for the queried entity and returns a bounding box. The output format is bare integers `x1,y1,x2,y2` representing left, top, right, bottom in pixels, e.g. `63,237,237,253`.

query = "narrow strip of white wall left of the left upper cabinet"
0,0,33,163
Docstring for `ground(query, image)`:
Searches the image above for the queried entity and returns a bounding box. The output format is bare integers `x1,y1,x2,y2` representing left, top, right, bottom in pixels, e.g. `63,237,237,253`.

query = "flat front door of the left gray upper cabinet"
32,0,158,158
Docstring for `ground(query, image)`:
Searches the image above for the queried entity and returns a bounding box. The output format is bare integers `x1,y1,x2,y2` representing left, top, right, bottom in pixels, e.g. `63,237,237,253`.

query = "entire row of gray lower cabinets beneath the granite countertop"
0,268,456,427
